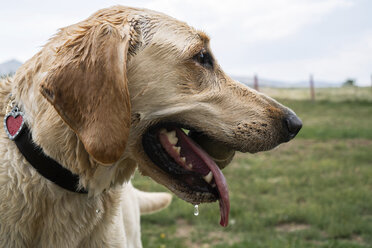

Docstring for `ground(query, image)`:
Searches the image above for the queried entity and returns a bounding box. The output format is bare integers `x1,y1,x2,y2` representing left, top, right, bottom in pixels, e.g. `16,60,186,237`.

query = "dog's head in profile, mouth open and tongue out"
37,6,302,225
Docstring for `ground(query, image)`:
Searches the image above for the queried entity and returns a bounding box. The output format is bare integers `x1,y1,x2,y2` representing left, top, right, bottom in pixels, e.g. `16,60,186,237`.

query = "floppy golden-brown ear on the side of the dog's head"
40,23,131,165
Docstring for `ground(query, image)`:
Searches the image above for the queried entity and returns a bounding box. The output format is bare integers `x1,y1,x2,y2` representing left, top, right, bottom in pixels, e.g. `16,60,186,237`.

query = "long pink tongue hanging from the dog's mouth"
159,128,230,227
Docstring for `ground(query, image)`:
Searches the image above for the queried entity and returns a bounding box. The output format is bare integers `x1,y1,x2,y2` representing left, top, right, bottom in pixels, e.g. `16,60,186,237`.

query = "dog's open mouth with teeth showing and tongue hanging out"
142,124,234,226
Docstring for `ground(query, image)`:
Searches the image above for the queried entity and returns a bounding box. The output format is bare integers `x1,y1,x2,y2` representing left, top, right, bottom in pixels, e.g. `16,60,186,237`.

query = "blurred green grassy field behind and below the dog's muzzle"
134,88,372,248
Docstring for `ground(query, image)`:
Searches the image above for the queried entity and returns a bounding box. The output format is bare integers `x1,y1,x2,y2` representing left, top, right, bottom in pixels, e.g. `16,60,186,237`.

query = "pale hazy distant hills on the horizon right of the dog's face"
231,76,342,88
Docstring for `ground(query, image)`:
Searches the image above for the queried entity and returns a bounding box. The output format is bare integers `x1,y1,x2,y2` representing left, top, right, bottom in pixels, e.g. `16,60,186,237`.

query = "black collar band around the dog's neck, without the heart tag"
4,106,88,194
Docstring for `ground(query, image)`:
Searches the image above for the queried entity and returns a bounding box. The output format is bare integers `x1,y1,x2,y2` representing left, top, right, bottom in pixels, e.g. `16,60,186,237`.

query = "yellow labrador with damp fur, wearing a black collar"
0,6,302,247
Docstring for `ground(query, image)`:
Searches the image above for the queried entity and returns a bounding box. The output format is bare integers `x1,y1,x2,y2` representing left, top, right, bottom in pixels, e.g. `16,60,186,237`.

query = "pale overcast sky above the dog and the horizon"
0,0,372,85
